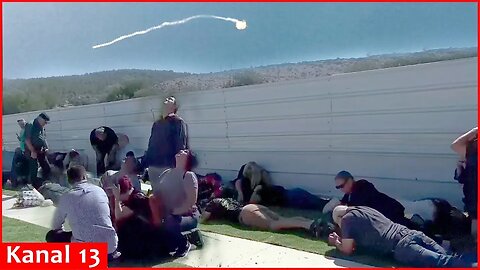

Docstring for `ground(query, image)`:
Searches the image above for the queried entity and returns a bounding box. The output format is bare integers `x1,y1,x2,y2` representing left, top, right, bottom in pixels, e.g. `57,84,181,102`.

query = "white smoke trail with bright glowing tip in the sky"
92,15,247,49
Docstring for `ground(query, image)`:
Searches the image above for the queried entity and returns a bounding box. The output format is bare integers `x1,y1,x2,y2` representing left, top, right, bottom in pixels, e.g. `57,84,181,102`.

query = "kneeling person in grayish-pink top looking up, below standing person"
150,150,203,256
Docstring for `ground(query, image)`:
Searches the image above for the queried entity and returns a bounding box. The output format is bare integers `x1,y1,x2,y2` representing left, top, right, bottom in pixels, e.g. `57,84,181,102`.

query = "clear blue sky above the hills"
2,3,477,78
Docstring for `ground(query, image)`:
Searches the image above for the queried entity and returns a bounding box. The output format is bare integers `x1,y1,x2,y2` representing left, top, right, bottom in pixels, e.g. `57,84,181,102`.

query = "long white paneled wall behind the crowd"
3,58,478,206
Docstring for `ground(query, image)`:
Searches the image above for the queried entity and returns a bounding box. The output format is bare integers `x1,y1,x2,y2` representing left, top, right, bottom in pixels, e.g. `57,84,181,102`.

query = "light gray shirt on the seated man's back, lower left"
58,182,117,253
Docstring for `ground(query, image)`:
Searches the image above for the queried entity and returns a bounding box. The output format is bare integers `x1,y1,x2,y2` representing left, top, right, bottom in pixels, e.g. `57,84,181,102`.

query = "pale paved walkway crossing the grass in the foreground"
2,195,370,268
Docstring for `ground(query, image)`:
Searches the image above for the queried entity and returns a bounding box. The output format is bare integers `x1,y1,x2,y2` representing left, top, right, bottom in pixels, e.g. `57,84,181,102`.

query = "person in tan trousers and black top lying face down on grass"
201,198,330,238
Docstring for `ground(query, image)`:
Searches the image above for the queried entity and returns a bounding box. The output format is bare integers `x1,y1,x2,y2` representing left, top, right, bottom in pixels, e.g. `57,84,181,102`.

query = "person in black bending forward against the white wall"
90,126,119,176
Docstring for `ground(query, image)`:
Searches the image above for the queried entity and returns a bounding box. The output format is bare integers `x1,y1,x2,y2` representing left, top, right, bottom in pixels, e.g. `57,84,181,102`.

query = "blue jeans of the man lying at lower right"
394,230,470,267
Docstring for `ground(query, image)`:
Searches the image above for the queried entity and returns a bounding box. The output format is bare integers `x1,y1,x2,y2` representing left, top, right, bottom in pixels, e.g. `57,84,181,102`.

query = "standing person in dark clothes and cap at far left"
25,113,50,189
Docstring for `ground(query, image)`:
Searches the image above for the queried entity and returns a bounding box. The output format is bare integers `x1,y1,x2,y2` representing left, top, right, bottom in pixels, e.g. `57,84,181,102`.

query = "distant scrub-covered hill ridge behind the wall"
3,48,477,114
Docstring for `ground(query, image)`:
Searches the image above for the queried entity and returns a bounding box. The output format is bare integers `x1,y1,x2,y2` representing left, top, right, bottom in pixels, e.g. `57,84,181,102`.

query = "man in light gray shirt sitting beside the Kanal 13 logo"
46,165,120,259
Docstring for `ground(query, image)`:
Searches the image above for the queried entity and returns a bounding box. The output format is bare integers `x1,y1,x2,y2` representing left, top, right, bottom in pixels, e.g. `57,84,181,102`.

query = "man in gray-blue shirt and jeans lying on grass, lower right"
328,205,473,267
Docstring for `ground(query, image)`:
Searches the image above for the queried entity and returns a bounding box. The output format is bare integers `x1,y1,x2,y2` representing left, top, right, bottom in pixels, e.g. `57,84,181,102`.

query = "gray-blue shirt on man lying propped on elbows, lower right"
341,206,408,254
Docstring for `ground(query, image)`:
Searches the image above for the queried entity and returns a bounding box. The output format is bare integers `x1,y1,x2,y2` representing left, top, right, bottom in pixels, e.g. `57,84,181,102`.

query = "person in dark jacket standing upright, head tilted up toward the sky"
146,97,188,180
